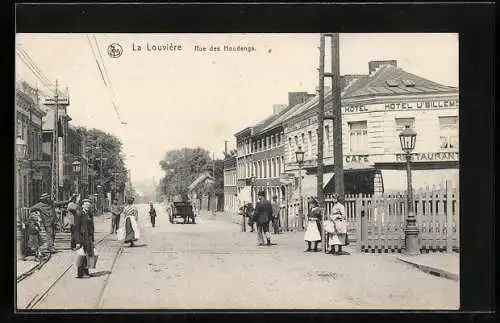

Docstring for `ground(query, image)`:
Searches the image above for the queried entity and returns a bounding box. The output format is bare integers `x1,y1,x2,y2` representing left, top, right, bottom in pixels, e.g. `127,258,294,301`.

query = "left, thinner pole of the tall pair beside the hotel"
316,34,327,252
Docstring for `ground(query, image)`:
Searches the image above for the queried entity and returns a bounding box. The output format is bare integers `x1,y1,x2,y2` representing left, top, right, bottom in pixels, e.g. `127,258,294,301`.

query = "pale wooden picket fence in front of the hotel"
281,182,460,252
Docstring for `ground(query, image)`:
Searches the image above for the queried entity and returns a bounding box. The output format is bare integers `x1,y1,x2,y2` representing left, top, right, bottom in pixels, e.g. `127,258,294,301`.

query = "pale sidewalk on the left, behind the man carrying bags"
16,213,111,280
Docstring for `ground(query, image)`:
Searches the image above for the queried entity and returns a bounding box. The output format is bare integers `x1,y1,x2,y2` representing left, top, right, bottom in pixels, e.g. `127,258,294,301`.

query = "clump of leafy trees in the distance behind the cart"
158,147,236,202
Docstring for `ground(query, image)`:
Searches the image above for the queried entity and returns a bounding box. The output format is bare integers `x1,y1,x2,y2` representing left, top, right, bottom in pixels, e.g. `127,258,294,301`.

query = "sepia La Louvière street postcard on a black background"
14,33,460,311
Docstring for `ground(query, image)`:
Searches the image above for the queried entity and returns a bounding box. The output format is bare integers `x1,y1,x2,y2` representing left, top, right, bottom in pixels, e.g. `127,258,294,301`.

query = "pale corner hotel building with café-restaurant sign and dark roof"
284,61,459,196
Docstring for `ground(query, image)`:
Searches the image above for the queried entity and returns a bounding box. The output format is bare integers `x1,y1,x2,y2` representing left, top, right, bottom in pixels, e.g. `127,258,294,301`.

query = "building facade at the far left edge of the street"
15,81,50,208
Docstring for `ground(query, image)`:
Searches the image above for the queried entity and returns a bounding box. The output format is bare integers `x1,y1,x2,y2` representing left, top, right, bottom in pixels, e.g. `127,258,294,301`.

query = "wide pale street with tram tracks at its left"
18,205,459,309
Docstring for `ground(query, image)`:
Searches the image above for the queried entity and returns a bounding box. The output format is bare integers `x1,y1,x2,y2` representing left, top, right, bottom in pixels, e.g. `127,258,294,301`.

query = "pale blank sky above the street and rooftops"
15,33,459,186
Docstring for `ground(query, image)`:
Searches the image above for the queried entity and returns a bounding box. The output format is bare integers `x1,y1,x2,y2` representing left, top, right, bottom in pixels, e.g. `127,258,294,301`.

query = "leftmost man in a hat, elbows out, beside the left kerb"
30,193,71,253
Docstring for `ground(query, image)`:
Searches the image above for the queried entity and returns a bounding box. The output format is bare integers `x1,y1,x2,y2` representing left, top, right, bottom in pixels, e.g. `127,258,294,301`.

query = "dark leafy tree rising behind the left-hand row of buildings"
77,127,128,197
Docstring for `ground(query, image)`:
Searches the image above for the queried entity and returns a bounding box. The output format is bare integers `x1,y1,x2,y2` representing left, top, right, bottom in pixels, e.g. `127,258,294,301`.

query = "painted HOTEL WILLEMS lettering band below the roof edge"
342,100,458,114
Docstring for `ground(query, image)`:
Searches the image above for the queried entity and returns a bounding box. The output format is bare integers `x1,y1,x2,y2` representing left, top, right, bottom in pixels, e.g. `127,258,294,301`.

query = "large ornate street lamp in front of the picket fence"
399,125,420,256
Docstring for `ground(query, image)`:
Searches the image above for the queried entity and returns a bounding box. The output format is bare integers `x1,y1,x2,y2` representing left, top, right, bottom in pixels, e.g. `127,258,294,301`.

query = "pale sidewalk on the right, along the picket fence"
209,211,460,281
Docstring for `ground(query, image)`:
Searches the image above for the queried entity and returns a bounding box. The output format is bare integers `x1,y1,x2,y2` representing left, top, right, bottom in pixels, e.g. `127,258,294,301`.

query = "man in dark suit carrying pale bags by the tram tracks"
75,199,94,278
